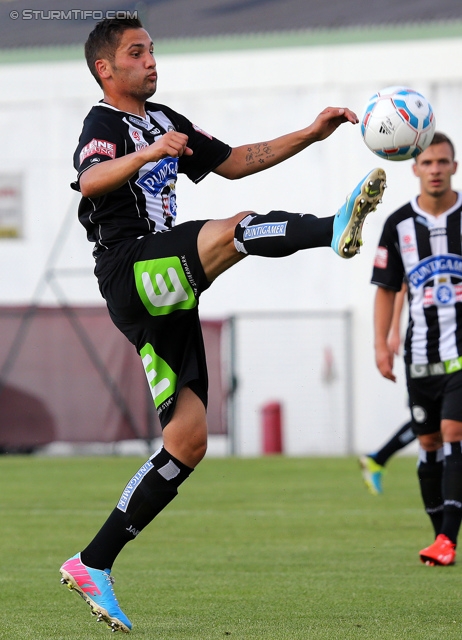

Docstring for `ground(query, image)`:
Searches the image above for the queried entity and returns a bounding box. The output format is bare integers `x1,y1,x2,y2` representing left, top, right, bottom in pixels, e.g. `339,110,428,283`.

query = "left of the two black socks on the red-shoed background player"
417,447,444,536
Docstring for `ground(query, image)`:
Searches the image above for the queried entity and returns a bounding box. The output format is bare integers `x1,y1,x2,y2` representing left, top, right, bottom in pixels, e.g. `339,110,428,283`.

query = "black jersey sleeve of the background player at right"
371,218,405,291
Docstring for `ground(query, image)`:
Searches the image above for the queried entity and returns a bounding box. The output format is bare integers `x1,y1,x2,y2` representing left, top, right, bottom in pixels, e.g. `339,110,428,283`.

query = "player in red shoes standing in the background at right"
372,132,462,565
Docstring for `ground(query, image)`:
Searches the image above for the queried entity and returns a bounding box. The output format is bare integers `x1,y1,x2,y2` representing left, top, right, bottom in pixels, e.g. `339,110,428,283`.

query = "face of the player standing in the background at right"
414,142,457,197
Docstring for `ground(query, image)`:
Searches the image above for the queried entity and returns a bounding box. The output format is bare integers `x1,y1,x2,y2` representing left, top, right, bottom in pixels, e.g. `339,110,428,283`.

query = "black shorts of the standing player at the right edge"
406,366,462,436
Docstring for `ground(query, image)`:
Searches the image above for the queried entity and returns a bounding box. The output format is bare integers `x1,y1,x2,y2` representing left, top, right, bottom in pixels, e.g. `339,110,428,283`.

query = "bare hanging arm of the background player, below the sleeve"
374,287,396,382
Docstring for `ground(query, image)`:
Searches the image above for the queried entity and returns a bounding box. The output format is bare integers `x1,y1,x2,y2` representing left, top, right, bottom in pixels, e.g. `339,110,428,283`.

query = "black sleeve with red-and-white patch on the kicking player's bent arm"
71,108,125,191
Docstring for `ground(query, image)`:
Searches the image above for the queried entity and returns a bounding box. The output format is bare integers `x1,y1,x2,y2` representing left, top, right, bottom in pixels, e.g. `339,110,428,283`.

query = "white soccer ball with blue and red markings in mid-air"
361,87,436,160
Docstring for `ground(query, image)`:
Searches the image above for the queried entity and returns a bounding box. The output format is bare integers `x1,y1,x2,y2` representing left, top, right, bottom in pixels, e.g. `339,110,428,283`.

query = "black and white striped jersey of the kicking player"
71,102,231,250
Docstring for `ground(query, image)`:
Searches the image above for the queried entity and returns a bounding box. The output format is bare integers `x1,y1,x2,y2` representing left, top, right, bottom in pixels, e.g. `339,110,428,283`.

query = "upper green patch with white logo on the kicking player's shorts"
133,256,197,316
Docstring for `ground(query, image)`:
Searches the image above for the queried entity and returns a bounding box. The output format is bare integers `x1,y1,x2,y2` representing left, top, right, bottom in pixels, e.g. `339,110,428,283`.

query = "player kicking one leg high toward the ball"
61,19,385,632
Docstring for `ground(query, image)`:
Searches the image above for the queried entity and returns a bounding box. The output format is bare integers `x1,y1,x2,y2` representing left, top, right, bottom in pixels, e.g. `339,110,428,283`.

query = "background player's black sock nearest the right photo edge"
440,442,462,543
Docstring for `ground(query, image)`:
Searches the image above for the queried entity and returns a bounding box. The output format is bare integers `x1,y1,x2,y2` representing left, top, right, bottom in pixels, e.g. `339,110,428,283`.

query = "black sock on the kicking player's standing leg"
80,447,192,570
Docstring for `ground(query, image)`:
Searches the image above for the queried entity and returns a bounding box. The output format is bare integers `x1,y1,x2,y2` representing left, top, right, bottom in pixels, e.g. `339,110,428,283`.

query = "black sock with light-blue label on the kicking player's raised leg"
234,211,334,258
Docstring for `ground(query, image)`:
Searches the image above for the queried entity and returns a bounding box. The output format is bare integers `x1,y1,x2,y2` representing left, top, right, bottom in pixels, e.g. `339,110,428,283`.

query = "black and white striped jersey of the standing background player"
372,193,462,364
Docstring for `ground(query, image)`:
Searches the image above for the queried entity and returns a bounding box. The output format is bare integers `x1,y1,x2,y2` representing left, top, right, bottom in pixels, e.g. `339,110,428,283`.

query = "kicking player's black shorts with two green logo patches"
95,220,210,428
